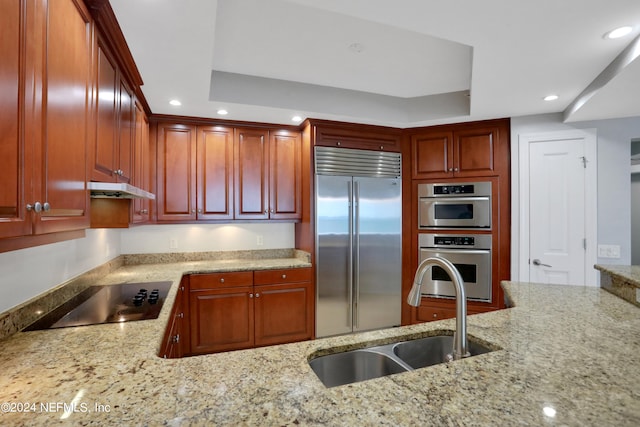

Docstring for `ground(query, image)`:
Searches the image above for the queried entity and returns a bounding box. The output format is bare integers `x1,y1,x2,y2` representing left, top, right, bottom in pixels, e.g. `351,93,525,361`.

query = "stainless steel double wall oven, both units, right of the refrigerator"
418,181,493,302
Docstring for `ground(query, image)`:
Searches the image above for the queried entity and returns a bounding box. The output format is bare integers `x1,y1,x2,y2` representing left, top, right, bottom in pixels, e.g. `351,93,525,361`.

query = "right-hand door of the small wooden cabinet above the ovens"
453,127,498,177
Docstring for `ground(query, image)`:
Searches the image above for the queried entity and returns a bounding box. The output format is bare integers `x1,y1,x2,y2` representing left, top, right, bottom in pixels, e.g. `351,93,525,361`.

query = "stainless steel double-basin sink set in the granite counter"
309,335,493,387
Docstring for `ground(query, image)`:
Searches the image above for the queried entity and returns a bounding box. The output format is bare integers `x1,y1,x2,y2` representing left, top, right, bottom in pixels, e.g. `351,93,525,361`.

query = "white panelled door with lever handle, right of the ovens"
521,131,597,285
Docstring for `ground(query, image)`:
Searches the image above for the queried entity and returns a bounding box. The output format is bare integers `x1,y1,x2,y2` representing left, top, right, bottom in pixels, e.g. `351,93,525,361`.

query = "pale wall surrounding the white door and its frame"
511,113,640,277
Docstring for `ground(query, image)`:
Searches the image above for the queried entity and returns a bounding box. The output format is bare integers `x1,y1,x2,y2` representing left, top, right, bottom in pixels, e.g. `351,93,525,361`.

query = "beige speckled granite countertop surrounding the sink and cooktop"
0,274,640,426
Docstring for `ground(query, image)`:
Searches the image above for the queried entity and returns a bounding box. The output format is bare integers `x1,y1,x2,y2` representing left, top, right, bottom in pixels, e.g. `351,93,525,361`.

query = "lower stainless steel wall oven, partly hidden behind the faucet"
418,233,492,302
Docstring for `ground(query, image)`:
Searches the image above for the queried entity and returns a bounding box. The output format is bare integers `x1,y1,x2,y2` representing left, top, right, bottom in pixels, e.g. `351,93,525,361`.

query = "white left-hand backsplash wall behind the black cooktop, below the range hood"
0,230,120,313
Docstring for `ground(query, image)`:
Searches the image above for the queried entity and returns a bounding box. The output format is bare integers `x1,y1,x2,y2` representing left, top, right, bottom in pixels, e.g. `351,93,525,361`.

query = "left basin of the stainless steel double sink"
309,349,408,387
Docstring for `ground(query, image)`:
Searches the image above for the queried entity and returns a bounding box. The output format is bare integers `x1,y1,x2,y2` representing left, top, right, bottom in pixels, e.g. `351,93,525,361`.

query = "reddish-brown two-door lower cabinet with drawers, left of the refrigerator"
182,268,313,355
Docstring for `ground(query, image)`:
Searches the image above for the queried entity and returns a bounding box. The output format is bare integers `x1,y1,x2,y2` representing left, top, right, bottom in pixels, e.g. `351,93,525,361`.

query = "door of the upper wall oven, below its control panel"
418,196,491,230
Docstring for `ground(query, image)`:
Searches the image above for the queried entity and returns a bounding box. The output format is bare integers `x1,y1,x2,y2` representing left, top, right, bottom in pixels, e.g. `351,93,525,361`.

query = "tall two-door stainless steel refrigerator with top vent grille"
315,147,402,337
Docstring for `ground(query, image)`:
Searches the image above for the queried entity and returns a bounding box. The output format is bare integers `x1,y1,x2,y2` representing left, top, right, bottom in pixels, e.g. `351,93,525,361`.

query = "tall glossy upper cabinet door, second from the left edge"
35,0,94,233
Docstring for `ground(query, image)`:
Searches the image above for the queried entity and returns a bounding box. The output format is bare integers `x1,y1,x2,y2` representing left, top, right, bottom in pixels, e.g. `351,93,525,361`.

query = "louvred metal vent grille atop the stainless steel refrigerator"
316,147,402,178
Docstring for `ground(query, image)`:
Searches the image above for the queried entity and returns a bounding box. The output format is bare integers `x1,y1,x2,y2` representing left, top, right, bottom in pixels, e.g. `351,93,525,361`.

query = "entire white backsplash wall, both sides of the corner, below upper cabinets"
0,223,295,313
